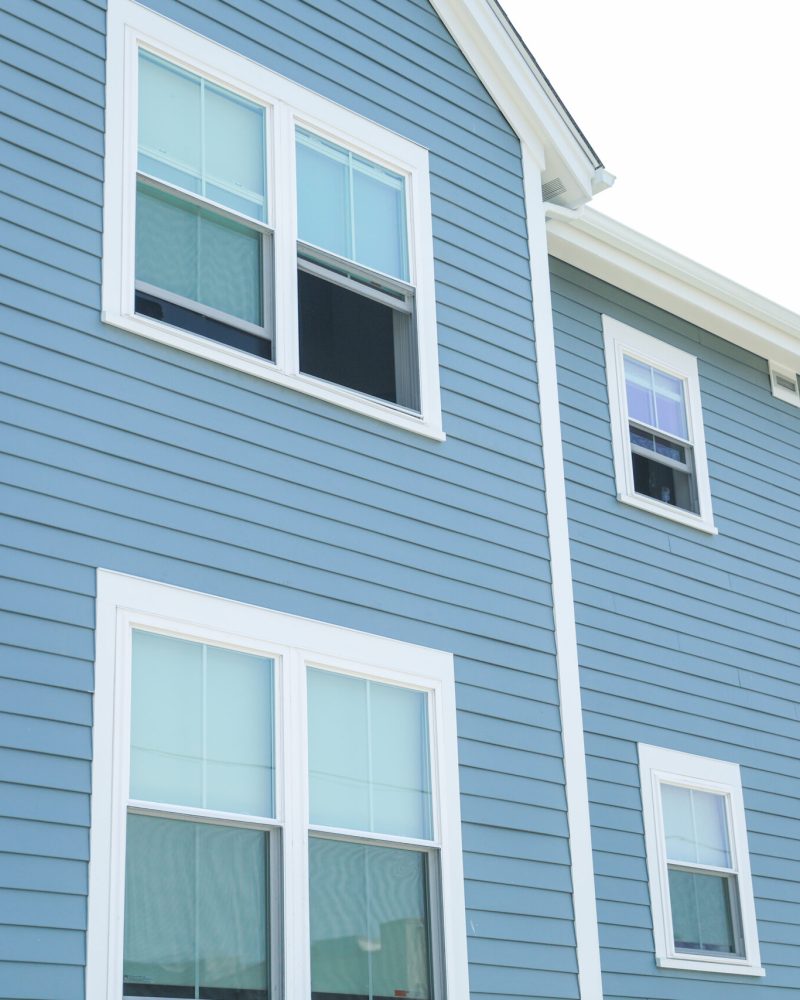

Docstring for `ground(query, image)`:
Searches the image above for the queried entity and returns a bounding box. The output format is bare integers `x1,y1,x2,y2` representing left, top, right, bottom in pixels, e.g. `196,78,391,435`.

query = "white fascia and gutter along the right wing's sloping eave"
547,208,800,372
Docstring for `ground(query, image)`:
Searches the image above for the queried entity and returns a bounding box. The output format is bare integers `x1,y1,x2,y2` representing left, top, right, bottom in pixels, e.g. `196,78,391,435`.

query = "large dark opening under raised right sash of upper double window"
298,269,419,409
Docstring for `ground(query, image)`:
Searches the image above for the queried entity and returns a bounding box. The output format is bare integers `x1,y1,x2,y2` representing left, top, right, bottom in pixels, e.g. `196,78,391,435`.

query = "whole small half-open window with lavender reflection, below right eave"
603,316,715,532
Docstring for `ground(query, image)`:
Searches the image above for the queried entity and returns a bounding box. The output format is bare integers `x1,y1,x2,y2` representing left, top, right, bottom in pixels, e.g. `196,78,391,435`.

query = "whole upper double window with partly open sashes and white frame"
103,0,441,437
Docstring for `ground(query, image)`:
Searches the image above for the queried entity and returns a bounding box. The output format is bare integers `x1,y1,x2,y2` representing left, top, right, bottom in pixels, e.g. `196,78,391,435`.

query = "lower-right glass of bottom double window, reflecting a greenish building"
309,837,431,1000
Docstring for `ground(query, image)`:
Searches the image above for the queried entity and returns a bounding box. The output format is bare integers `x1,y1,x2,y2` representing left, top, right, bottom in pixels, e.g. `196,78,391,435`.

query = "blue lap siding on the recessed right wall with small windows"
552,261,800,1000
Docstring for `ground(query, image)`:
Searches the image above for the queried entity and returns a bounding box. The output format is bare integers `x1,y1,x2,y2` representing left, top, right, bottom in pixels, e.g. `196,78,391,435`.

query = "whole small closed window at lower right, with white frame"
639,744,763,976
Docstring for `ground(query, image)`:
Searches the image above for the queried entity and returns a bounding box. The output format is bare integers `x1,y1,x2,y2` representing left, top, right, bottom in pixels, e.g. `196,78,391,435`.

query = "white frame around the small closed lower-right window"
639,743,765,976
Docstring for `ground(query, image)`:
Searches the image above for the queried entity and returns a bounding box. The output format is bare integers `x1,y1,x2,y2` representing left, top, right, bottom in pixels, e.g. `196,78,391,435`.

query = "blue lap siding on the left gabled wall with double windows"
0,0,577,1000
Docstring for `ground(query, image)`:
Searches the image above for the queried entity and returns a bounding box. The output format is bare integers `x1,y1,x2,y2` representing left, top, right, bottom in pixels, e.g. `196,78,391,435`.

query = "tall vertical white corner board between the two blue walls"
522,145,603,1000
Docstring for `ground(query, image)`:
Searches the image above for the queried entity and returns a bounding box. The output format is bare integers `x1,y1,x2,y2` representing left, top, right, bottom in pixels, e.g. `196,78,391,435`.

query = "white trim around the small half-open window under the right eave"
603,316,718,535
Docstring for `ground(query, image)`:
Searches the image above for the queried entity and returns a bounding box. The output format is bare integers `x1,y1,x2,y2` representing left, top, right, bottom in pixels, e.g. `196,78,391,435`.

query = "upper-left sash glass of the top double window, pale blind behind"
139,51,267,221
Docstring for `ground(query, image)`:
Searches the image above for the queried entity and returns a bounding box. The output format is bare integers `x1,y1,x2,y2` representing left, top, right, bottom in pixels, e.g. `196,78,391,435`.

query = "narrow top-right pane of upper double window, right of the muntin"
353,157,408,281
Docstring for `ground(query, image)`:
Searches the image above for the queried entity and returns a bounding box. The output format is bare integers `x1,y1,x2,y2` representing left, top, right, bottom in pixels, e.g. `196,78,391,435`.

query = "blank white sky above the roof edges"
501,0,800,313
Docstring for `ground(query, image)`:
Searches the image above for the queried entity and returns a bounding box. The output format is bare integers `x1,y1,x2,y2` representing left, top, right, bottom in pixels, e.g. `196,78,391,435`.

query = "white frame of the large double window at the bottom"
86,569,469,1000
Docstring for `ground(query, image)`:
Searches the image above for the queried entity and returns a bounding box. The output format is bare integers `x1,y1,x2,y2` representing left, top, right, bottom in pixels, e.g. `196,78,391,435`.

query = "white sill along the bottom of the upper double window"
101,312,446,441
